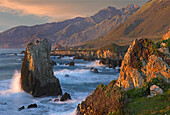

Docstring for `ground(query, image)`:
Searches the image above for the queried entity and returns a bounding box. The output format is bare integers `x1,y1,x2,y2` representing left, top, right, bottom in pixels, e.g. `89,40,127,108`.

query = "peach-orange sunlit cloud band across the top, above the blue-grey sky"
0,0,147,21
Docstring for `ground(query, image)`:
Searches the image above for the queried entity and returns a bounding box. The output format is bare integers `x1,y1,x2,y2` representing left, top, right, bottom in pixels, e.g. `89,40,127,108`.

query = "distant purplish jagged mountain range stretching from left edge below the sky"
0,4,139,48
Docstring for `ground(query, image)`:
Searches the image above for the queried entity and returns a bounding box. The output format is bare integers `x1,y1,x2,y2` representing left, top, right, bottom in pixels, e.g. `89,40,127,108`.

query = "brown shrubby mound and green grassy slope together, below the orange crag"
78,77,170,115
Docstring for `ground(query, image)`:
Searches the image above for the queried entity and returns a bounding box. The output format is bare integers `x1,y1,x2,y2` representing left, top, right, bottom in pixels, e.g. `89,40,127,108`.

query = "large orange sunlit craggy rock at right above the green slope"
117,38,170,90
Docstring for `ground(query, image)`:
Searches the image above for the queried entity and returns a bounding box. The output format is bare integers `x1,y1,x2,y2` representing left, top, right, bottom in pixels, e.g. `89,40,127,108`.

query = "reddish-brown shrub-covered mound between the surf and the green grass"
77,81,124,115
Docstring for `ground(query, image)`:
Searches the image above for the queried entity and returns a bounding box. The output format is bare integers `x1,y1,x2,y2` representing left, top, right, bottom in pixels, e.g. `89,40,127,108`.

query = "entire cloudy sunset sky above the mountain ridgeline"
0,0,148,32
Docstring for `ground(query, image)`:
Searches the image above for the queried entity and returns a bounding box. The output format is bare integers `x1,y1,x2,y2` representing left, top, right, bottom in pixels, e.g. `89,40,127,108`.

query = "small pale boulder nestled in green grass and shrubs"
150,85,163,96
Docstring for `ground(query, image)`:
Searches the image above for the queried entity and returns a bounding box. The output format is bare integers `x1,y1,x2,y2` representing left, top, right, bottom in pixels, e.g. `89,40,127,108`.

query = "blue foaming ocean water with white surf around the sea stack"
0,49,119,115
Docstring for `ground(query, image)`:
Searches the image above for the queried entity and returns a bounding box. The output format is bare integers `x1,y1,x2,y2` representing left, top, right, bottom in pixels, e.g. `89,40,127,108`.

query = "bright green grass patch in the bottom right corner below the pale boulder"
125,89,170,115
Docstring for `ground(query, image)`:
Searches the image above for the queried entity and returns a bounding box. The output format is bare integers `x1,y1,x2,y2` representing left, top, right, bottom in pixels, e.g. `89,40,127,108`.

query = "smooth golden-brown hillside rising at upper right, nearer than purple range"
83,0,170,47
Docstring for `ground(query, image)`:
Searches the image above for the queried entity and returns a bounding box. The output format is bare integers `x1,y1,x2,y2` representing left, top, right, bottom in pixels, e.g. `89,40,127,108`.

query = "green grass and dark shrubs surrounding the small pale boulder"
124,77,170,115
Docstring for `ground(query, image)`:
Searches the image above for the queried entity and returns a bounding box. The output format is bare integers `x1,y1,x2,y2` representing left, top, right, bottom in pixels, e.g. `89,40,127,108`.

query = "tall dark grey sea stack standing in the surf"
21,39,62,97
